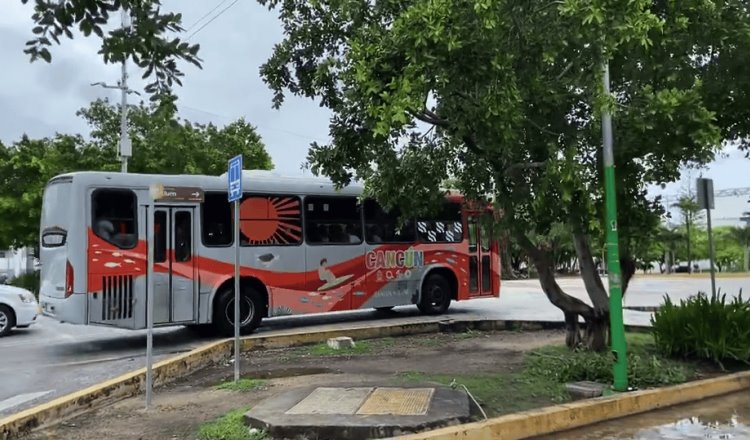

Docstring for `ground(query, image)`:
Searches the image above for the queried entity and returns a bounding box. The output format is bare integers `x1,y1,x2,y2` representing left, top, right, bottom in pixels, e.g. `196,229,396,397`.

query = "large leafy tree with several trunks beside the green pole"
260,0,748,350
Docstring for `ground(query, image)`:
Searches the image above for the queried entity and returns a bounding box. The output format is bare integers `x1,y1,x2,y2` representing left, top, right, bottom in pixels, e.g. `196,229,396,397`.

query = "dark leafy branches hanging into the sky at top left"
21,0,201,101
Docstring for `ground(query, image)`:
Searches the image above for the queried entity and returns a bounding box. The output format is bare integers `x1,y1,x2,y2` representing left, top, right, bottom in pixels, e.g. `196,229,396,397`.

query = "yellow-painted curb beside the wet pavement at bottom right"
394,371,750,440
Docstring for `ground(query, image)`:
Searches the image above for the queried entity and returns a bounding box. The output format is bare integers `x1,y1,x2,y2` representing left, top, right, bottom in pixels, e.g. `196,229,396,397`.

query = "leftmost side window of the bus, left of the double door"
91,189,138,249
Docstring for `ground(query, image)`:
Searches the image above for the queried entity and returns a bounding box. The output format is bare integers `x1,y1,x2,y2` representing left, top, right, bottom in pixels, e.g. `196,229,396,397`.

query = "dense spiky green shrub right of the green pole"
651,291,750,368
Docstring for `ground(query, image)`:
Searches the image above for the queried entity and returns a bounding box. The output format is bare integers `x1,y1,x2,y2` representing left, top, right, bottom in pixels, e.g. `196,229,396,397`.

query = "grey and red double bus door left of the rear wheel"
154,205,198,324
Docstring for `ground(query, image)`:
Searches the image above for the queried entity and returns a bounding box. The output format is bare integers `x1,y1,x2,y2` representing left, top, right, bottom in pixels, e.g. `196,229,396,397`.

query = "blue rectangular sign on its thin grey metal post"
227,155,242,382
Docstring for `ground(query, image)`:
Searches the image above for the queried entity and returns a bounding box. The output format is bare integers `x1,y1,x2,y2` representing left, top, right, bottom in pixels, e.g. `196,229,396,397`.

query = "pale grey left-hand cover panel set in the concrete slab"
286,387,372,415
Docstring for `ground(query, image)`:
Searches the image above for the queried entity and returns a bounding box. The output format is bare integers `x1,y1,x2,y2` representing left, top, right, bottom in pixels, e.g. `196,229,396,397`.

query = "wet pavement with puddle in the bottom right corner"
537,391,750,440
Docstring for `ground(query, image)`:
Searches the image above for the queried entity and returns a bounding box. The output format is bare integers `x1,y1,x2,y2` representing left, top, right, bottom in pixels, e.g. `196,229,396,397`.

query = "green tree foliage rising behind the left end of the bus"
0,100,273,248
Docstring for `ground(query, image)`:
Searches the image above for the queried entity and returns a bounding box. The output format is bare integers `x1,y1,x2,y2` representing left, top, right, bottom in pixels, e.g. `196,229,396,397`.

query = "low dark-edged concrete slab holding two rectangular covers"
245,385,472,440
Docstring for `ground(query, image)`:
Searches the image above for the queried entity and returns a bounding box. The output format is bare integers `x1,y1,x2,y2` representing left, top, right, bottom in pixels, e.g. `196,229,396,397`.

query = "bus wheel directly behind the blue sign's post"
213,286,264,337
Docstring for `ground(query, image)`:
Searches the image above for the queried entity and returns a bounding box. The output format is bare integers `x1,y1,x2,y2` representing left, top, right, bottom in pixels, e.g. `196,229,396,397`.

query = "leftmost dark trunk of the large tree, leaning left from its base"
515,232,600,349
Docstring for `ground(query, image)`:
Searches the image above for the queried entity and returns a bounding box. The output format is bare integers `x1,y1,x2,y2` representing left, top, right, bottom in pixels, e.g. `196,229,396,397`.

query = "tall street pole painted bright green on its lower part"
602,62,628,391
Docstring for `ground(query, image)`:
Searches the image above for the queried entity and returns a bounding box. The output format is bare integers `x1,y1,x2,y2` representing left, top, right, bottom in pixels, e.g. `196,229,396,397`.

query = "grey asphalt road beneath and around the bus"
0,277,750,418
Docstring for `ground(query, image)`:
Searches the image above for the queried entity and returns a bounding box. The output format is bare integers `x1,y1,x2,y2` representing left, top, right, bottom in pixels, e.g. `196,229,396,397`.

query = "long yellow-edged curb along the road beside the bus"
0,318,650,440
